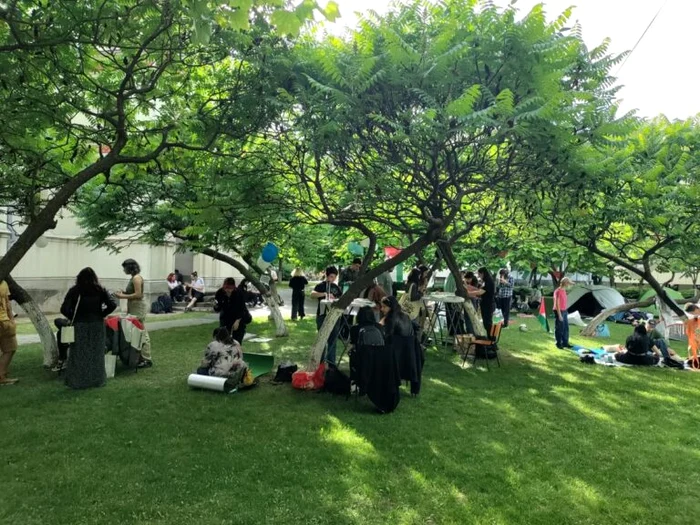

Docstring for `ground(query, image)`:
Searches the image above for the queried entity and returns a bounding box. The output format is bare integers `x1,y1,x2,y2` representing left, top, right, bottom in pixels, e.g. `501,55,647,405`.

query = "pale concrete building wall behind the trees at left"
0,213,241,313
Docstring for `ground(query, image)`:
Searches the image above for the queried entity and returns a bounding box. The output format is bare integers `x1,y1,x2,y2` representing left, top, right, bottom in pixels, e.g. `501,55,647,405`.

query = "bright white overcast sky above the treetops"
322,0,700,118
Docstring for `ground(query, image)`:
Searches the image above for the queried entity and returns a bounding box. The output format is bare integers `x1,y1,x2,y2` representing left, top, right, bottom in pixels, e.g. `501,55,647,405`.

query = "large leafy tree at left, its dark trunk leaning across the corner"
0,0,326,359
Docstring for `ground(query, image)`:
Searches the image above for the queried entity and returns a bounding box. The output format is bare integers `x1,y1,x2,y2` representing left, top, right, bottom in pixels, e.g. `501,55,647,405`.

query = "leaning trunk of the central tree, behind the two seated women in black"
308,227,443,370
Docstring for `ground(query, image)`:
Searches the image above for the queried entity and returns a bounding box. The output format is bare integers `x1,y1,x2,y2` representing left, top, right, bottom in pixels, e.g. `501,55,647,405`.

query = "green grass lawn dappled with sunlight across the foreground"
0,319,700,525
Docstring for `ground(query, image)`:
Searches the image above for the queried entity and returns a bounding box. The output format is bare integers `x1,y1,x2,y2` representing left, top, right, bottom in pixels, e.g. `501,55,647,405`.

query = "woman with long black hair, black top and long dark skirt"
61,268,117,389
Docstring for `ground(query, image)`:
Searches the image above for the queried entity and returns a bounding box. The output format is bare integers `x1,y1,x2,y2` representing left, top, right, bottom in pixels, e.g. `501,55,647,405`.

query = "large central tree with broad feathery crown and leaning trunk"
268,0,628,362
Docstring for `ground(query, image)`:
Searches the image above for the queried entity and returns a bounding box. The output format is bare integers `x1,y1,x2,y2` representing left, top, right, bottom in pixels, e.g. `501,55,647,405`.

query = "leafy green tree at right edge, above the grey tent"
542,117,700,315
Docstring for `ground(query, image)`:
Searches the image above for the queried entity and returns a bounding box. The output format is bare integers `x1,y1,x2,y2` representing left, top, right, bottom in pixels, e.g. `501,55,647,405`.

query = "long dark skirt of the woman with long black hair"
65,321,107,388
